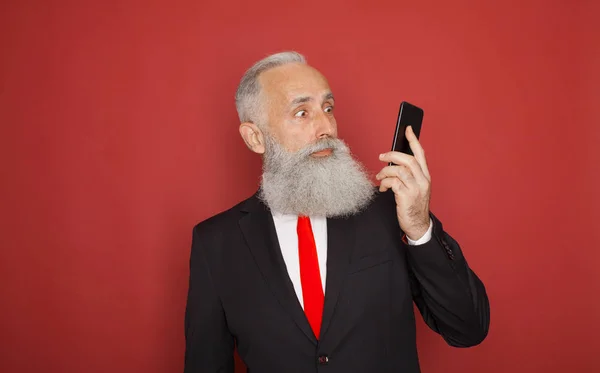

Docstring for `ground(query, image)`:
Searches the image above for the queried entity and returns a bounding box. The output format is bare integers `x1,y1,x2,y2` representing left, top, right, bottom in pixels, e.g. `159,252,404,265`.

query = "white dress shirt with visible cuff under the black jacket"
272,213,433,308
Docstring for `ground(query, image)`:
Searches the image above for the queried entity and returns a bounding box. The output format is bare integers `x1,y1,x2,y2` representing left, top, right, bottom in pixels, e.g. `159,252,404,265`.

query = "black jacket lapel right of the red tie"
320,212,356,339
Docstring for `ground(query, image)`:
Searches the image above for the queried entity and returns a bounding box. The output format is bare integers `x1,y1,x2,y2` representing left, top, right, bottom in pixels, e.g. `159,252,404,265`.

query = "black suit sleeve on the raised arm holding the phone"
406,214,490,347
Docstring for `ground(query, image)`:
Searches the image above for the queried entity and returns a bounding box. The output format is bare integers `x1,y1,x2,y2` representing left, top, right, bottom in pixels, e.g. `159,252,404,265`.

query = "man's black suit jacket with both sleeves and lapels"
185,191,489,373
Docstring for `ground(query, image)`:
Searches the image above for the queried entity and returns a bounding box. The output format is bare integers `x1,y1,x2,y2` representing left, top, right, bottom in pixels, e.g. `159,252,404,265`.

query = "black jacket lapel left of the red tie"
239,195,317,345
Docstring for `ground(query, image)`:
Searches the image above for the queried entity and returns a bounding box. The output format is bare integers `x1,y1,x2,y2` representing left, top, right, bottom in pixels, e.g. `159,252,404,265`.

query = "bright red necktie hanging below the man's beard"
297,216,325,339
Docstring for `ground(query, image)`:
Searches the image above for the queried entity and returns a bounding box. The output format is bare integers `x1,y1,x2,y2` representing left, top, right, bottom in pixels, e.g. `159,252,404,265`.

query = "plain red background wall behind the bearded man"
0,0,600,373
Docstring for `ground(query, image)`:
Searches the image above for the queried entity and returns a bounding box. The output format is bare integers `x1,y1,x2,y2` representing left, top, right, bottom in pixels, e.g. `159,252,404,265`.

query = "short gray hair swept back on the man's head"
235,51,306,125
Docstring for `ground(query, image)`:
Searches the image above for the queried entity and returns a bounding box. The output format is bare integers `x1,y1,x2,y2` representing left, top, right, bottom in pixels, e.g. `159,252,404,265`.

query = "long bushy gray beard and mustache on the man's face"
259,134,375,217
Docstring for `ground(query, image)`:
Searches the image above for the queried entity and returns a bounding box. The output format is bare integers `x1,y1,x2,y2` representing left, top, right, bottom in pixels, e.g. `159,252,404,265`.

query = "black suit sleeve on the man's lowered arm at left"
184,228,234,373
